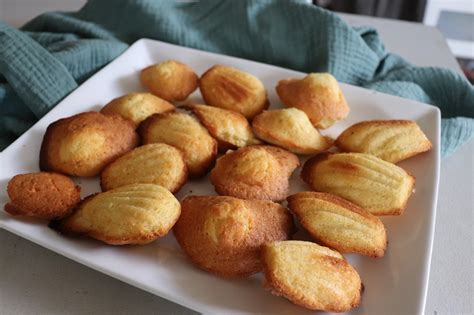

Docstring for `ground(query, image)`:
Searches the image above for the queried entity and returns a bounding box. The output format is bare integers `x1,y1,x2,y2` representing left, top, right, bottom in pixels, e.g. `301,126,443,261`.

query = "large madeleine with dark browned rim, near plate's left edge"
40,112,139,177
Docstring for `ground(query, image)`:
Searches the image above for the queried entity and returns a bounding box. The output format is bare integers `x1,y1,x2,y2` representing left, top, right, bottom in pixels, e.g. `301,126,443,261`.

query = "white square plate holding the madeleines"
0,39,440,314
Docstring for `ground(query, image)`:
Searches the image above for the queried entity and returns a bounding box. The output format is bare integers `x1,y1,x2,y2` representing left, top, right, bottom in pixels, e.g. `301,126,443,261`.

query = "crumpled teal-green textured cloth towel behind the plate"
0,0,474,156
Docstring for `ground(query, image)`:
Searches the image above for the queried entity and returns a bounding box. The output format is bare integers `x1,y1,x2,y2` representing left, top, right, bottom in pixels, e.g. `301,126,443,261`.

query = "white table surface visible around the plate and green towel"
0,0,474,315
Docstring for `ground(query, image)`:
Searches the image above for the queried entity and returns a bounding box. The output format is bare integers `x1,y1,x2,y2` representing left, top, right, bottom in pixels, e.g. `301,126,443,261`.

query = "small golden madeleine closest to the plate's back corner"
140,60,199,102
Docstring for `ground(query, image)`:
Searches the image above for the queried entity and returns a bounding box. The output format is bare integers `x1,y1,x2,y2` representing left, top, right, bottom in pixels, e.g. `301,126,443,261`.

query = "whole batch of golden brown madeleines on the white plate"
5,60,431,312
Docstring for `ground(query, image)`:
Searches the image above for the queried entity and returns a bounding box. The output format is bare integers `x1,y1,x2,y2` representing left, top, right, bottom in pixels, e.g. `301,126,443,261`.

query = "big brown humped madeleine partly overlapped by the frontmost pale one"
173,196,294,277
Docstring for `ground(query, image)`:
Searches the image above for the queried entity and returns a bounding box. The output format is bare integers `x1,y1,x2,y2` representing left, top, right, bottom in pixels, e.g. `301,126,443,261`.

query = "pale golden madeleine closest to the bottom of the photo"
263,241,362,312
